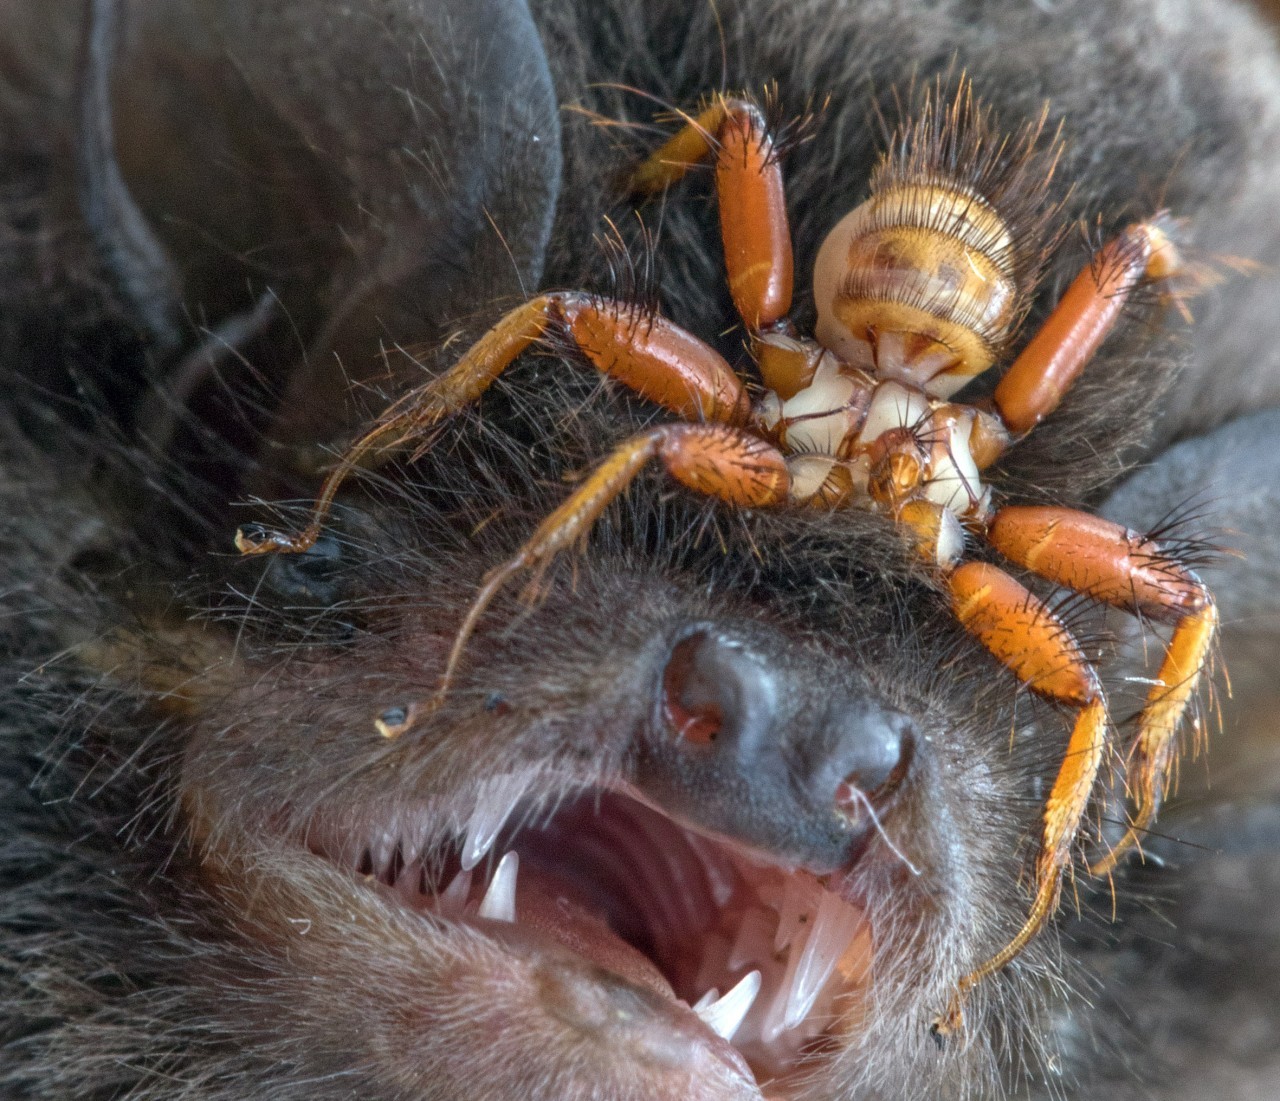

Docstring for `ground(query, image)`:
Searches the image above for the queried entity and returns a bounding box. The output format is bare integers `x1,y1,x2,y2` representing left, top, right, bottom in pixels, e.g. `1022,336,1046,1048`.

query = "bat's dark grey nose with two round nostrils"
637,626,915,868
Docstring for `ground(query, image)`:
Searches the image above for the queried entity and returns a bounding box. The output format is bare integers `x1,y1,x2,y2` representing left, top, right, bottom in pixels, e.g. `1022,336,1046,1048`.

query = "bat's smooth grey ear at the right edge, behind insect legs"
1102,410,1280,652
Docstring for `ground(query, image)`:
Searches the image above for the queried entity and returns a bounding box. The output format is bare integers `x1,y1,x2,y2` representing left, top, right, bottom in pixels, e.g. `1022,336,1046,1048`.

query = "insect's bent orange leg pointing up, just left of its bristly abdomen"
631,96,794,333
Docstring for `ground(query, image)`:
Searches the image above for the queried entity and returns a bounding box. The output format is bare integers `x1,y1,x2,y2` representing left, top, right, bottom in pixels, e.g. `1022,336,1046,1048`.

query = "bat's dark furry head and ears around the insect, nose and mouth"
0,0,1280,1101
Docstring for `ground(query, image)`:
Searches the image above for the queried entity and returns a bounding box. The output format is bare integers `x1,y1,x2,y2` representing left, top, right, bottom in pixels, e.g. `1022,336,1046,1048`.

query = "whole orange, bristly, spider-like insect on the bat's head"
237,82,1217,1034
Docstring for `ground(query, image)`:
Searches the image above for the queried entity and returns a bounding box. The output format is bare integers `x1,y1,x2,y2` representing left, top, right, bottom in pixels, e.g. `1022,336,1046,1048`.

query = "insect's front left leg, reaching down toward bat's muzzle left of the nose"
435,424,790,702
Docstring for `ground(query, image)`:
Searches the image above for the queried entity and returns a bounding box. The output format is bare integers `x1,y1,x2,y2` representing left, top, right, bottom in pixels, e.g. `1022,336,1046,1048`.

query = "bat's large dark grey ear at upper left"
76,0,561,478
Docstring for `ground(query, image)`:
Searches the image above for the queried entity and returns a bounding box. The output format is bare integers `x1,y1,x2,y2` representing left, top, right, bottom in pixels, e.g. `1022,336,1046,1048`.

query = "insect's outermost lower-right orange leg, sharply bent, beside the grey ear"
988,506,1217,874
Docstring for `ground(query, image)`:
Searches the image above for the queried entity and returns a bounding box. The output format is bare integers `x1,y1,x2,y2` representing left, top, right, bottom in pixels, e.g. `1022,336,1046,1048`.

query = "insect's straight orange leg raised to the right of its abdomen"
995,221,1179,435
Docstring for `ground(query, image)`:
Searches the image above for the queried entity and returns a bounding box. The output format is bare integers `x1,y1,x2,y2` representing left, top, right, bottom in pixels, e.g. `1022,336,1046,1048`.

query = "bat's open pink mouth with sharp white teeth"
307,778,872,1086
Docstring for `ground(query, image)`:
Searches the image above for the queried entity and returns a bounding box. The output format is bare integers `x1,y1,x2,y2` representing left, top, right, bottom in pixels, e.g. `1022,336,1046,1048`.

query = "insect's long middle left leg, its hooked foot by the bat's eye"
236,292,750,554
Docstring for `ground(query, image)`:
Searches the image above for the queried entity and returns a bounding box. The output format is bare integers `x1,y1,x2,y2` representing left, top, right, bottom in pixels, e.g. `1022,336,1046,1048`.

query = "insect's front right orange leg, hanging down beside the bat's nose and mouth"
933,562,1107,1036
